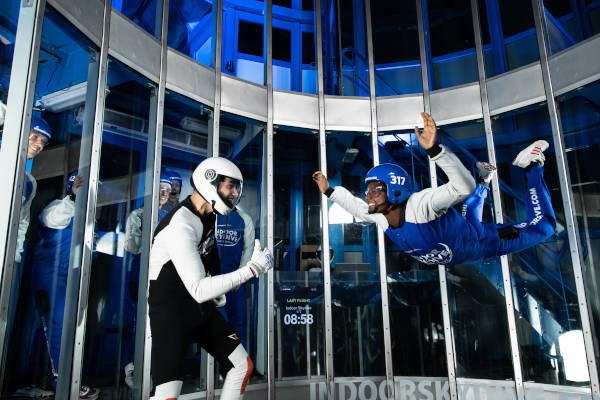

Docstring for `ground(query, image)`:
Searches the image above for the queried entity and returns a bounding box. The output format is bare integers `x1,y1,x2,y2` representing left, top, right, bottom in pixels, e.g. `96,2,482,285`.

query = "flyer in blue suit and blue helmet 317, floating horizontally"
313,113,556,266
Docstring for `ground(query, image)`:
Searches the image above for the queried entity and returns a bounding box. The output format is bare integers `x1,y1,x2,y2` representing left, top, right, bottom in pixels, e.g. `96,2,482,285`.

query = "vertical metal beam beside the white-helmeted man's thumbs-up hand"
261,0,275,400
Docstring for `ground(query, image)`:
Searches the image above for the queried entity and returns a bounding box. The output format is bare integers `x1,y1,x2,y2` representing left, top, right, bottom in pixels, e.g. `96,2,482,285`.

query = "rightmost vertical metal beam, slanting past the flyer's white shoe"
531,0,600,399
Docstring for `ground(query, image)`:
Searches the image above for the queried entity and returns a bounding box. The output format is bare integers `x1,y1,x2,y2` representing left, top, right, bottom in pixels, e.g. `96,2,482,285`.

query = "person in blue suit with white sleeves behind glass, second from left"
31,171,100,399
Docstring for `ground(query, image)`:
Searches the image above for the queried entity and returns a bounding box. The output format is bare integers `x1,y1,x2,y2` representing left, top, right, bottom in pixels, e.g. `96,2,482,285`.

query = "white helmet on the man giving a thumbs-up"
192,157,244,215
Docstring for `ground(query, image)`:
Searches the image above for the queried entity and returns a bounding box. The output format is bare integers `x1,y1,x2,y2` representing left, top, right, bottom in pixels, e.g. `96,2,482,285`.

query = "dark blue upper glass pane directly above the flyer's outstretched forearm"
318,0,369,96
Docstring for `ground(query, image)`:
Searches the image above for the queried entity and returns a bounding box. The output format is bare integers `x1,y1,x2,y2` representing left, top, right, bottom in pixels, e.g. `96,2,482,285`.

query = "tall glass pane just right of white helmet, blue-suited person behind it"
215,113,267,388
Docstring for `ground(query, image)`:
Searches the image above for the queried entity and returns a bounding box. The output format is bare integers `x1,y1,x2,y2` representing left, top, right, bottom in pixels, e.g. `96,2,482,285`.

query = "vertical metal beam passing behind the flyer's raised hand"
416,0,458,400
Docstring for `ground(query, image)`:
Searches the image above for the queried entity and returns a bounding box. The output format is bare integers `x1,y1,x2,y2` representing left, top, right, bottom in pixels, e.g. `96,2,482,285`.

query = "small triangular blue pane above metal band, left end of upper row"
111,0,162,39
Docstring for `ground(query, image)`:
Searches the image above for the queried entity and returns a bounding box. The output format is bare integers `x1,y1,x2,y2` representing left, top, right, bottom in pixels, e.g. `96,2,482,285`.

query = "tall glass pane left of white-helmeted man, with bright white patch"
83,58,158,394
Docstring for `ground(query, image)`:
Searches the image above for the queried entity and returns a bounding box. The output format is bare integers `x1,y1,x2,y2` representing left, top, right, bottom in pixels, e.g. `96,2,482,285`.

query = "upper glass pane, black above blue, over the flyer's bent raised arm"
423,0,479,90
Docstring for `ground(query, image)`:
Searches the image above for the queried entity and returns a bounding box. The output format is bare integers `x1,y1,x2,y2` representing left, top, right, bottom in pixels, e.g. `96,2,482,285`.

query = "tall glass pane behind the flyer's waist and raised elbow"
438,122,514,380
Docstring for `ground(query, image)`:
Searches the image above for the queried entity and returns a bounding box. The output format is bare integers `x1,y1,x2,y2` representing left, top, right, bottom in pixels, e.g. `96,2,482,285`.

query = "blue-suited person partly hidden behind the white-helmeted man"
215,207,255,349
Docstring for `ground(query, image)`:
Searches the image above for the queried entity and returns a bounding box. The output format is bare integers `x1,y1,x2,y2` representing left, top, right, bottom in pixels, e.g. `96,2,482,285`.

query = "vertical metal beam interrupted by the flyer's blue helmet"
364,0,395,397
